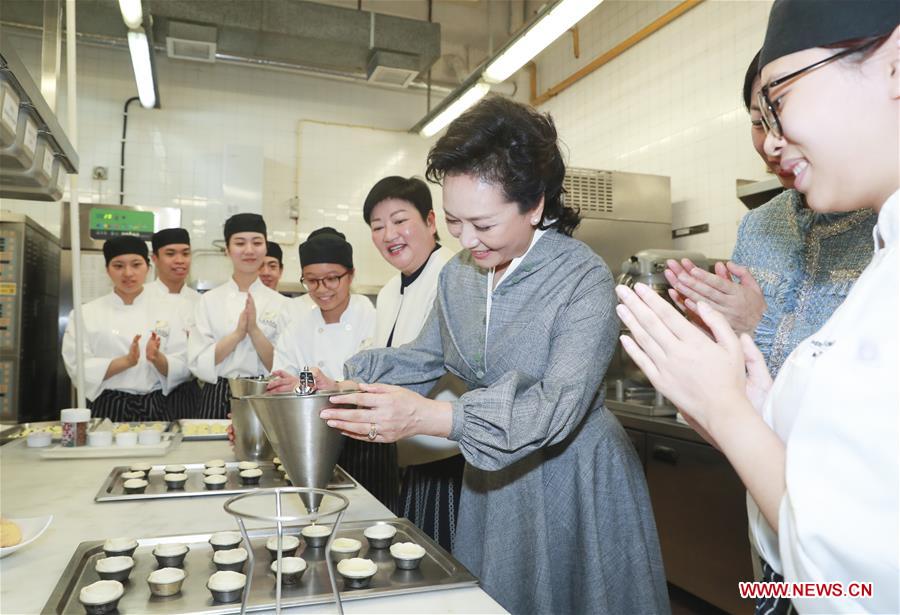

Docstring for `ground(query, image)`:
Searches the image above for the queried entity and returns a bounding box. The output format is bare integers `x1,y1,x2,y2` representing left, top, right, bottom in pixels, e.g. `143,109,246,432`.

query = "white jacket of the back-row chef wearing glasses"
273,295,375,379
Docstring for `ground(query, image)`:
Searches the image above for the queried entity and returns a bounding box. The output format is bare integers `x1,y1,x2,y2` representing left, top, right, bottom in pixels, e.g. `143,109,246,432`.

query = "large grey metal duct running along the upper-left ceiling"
0,0,441,85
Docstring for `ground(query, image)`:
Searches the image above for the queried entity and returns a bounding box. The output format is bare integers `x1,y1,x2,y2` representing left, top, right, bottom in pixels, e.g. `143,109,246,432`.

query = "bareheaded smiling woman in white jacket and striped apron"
363,176,465,551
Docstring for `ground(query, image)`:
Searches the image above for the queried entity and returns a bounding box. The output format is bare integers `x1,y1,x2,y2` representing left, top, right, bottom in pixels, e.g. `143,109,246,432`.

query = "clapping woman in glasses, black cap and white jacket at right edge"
618,0,900,613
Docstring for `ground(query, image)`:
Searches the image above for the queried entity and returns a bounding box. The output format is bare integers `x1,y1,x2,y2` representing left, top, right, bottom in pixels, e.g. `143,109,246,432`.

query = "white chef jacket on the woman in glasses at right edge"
748,193,900,613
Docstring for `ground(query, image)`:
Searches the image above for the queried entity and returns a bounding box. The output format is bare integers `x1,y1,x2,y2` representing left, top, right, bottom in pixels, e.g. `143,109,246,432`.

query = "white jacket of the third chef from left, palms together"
188,278,289,383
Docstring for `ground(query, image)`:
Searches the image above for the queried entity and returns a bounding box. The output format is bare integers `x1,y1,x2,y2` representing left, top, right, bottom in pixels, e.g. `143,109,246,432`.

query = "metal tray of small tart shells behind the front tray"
94,461,356,502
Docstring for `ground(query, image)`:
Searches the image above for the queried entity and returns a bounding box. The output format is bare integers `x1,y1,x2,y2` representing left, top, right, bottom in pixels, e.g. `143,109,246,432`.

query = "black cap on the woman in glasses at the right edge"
759,0,900,70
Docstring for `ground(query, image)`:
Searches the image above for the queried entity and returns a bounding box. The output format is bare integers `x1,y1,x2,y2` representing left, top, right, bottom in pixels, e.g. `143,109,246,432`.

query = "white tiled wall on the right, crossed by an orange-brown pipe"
537,0,771,257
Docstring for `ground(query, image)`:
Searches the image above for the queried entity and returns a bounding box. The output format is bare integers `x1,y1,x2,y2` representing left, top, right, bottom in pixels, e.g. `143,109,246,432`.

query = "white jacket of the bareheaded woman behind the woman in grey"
375,247,465,466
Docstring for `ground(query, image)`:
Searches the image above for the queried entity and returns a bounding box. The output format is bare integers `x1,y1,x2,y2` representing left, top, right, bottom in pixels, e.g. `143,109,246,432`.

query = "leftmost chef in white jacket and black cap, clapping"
62,236,190,421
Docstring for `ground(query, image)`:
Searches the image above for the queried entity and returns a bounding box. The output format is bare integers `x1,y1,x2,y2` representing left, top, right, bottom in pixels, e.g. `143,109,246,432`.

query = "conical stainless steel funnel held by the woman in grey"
242,391,352,512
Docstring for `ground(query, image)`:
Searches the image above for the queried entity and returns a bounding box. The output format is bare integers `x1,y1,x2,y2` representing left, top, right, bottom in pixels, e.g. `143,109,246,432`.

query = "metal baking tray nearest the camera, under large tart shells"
42,519,478,615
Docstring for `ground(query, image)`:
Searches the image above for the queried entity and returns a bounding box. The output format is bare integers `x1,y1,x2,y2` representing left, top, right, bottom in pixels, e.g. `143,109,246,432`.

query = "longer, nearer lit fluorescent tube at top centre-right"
484,0,603,83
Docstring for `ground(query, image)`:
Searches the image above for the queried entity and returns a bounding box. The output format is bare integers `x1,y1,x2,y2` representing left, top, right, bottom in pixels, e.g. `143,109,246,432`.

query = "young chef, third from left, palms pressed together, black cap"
188,214,287,419
